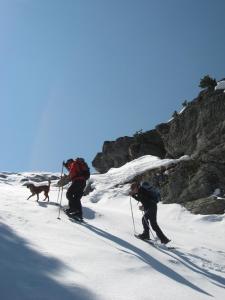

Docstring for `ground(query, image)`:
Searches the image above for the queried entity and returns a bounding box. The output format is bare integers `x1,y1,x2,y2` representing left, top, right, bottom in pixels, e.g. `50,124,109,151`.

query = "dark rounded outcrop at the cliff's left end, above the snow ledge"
92,130,166,173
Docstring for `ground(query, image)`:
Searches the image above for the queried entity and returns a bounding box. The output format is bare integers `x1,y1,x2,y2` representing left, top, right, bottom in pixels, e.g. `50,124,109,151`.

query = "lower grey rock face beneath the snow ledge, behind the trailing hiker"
131,159,225,214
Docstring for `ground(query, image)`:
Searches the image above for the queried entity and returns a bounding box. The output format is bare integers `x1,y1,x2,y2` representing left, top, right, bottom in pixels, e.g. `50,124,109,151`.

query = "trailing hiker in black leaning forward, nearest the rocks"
130,182,170,244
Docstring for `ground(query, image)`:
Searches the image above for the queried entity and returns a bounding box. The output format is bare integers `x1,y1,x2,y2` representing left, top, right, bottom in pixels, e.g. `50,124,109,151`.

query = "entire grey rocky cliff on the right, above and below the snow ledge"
93,90,225,214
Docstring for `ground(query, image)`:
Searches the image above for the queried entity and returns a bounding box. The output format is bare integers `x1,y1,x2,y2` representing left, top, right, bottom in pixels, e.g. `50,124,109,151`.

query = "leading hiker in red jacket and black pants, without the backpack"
64,159,86,220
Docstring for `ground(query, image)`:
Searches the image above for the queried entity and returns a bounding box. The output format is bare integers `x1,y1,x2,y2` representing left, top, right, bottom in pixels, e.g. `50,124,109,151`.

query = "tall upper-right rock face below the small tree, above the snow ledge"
156,91,225,161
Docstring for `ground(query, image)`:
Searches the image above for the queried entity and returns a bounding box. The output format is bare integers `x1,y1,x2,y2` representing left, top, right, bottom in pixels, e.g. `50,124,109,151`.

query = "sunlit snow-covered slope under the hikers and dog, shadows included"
0,156,225,300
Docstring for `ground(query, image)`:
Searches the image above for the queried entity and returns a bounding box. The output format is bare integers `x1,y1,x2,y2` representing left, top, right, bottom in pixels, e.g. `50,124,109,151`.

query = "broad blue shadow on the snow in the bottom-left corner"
0,223,96,300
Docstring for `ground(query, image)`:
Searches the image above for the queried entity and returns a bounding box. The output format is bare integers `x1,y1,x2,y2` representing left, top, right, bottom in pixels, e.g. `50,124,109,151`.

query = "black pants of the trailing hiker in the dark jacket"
142,203,168,242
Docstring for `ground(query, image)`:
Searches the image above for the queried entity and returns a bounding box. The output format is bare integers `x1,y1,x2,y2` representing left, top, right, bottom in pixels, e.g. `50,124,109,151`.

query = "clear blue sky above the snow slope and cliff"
0,0,225,172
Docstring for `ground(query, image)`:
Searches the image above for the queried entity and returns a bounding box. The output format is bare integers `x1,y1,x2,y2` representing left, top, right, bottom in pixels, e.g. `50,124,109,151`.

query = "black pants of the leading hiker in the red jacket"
66,180,86,217
